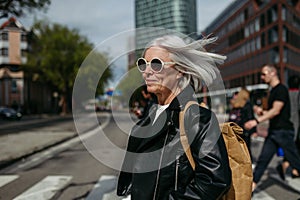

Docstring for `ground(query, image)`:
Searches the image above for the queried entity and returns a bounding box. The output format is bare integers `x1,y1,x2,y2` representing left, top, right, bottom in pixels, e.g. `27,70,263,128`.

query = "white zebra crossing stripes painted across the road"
0,175,300,200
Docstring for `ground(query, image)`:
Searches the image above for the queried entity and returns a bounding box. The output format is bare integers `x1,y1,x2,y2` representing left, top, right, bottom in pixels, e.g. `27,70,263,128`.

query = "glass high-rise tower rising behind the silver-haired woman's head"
135,0,197,54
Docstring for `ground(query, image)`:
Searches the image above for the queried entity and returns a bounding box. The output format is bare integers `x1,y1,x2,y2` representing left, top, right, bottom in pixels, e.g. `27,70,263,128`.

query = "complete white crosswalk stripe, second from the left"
14,176,72,200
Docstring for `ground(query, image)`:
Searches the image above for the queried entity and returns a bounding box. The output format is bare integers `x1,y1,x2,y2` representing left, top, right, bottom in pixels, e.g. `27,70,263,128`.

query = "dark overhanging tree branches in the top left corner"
0,0,51,19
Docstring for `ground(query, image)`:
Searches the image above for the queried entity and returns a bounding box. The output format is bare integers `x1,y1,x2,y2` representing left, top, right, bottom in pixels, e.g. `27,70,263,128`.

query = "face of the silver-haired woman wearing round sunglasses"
143,47,182,94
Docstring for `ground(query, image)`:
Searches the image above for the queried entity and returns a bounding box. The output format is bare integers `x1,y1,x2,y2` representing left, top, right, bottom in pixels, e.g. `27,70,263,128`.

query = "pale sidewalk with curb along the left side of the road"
0,113,109,169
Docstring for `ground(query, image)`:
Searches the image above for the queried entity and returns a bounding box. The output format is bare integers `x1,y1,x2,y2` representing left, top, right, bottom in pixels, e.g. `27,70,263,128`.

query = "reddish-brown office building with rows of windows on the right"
203,0,300,88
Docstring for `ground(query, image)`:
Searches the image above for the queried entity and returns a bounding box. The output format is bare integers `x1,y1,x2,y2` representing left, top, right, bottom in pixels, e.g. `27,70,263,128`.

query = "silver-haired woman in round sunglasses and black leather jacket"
117,35,231,200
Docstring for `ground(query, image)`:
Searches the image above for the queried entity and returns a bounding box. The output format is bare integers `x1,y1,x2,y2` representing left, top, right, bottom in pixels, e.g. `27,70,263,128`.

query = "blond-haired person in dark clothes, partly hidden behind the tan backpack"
228,88,256,160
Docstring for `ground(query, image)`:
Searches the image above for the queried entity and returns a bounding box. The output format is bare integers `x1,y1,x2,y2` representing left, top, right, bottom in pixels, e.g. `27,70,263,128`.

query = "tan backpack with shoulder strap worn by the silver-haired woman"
179,101,253,200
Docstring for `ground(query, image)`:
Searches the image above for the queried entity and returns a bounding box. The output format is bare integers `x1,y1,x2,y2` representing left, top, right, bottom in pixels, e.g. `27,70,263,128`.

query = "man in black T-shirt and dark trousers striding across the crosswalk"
245,65,300,190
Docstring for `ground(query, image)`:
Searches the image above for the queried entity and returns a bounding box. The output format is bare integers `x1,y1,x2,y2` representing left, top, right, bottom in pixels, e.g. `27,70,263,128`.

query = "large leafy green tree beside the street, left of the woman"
26,21,112,113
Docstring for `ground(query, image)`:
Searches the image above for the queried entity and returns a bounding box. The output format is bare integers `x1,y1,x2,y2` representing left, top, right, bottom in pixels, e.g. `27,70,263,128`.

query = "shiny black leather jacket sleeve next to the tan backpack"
179,105,231,200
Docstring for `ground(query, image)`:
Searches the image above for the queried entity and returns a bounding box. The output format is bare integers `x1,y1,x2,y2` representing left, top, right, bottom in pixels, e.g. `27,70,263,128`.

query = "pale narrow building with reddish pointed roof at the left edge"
0,18,28,106
